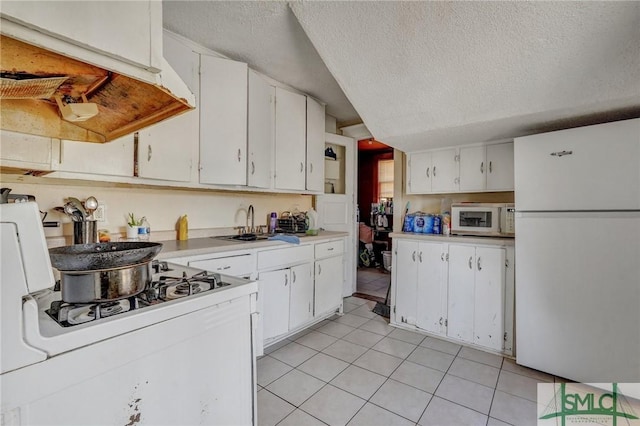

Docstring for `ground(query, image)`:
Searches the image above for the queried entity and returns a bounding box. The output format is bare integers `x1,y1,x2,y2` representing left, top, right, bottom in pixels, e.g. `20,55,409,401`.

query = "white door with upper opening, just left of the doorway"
315,133,358,297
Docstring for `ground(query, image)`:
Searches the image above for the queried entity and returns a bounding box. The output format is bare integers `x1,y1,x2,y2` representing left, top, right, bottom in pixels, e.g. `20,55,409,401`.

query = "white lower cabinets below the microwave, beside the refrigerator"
391,238,514,355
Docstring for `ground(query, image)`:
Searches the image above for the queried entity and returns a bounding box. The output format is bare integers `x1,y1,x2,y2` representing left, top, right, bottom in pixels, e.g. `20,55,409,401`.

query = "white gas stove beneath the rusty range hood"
0,203,257,425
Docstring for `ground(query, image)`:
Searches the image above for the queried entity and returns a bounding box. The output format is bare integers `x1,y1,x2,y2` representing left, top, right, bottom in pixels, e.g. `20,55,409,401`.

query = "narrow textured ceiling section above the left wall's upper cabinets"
162,0,360,122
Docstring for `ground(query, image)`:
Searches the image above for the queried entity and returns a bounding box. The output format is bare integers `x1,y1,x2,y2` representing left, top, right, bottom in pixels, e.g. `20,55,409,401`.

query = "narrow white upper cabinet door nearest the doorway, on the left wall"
306,96,325,192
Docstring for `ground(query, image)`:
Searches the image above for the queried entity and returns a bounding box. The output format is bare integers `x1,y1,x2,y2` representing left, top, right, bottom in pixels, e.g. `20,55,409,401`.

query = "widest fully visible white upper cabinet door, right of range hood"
200,55,248,185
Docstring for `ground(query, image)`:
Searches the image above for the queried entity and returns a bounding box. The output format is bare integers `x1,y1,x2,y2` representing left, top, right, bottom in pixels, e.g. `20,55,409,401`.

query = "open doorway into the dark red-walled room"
355,138,393,302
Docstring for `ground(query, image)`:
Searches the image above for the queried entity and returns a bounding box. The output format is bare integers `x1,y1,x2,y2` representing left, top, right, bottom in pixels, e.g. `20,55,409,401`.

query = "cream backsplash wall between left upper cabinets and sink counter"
2,178,312,245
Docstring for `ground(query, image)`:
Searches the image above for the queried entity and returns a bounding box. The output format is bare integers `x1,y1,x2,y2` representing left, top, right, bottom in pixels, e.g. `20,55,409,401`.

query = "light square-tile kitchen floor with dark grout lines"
258,297,562,426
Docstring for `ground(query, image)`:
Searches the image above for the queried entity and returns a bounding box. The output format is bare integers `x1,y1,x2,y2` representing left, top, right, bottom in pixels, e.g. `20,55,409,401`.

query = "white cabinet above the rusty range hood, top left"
2,0,162,72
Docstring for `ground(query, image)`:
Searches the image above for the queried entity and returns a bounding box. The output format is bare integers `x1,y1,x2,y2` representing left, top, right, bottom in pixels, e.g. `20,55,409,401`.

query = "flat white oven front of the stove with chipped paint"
0,296,255,425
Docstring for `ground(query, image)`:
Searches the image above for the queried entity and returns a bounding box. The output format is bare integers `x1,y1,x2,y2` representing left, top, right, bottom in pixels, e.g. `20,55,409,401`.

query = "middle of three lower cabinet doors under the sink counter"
289,263,313,330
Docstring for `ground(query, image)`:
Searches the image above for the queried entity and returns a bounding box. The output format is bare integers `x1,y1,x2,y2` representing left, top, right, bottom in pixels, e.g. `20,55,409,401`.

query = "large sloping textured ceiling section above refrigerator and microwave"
291,1,640,151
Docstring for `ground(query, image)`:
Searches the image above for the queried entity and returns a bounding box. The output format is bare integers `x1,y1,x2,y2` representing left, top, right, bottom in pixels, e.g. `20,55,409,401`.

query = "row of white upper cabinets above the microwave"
405,142,514,194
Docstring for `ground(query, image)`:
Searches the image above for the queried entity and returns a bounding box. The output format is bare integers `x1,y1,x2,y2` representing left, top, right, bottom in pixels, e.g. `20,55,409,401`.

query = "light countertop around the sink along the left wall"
157,231,349,260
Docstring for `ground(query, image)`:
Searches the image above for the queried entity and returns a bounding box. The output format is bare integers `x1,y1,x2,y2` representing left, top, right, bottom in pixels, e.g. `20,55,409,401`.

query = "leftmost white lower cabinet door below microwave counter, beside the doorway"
392,240,419,325
